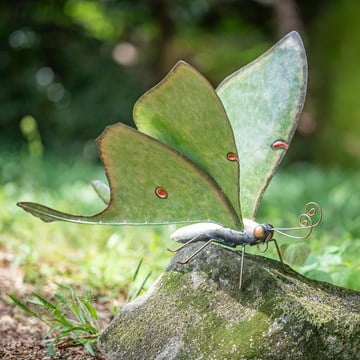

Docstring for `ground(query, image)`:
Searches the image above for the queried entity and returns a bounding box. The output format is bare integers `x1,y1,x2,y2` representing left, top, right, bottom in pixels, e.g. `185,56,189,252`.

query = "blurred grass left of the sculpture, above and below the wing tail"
0,153,174,295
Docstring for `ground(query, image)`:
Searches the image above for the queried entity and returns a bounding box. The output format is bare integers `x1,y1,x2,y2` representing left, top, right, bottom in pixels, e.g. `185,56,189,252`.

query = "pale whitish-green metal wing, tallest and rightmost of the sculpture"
216,32,307,218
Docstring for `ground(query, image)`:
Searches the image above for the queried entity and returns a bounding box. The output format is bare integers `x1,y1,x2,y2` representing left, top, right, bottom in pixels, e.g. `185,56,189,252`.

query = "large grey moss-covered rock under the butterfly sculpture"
99,244,360,360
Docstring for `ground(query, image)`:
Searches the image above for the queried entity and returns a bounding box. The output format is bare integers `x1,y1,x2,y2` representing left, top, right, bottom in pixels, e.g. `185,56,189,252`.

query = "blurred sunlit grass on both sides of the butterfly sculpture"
0,154,360,297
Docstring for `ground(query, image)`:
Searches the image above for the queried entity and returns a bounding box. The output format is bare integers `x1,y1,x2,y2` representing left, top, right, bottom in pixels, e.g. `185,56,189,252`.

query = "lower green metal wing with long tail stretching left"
18,123,240,228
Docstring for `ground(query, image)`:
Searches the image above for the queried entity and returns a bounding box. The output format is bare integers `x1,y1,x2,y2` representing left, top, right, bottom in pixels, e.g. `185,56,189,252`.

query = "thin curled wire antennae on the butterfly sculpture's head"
273,201,322,239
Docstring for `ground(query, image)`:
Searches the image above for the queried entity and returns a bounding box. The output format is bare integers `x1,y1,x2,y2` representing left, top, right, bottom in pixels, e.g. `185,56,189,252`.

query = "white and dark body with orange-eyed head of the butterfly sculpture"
171,219,274,247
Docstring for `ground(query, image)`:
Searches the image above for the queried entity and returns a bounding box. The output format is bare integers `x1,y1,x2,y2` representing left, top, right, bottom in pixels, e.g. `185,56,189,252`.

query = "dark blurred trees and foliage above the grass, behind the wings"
0,0,360,167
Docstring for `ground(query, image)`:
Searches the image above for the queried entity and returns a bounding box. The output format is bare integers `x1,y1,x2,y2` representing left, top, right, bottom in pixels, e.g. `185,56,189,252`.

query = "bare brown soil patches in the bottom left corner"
0,251,113,360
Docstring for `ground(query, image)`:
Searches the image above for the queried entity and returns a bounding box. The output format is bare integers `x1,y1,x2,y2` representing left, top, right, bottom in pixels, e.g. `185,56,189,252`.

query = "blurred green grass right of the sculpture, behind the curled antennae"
259,164,360,289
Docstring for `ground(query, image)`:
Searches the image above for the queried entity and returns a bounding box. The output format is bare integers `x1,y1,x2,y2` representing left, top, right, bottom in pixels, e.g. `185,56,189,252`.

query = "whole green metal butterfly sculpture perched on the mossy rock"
18,32,321,287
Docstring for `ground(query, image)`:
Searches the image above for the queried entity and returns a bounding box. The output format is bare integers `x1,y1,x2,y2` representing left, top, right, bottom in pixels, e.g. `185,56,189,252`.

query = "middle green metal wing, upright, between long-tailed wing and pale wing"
134,62,242,228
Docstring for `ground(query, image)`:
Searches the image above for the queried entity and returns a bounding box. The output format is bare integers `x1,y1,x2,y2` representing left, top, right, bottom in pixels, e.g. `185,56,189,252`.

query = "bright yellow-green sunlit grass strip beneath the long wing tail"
1,214,174,289
